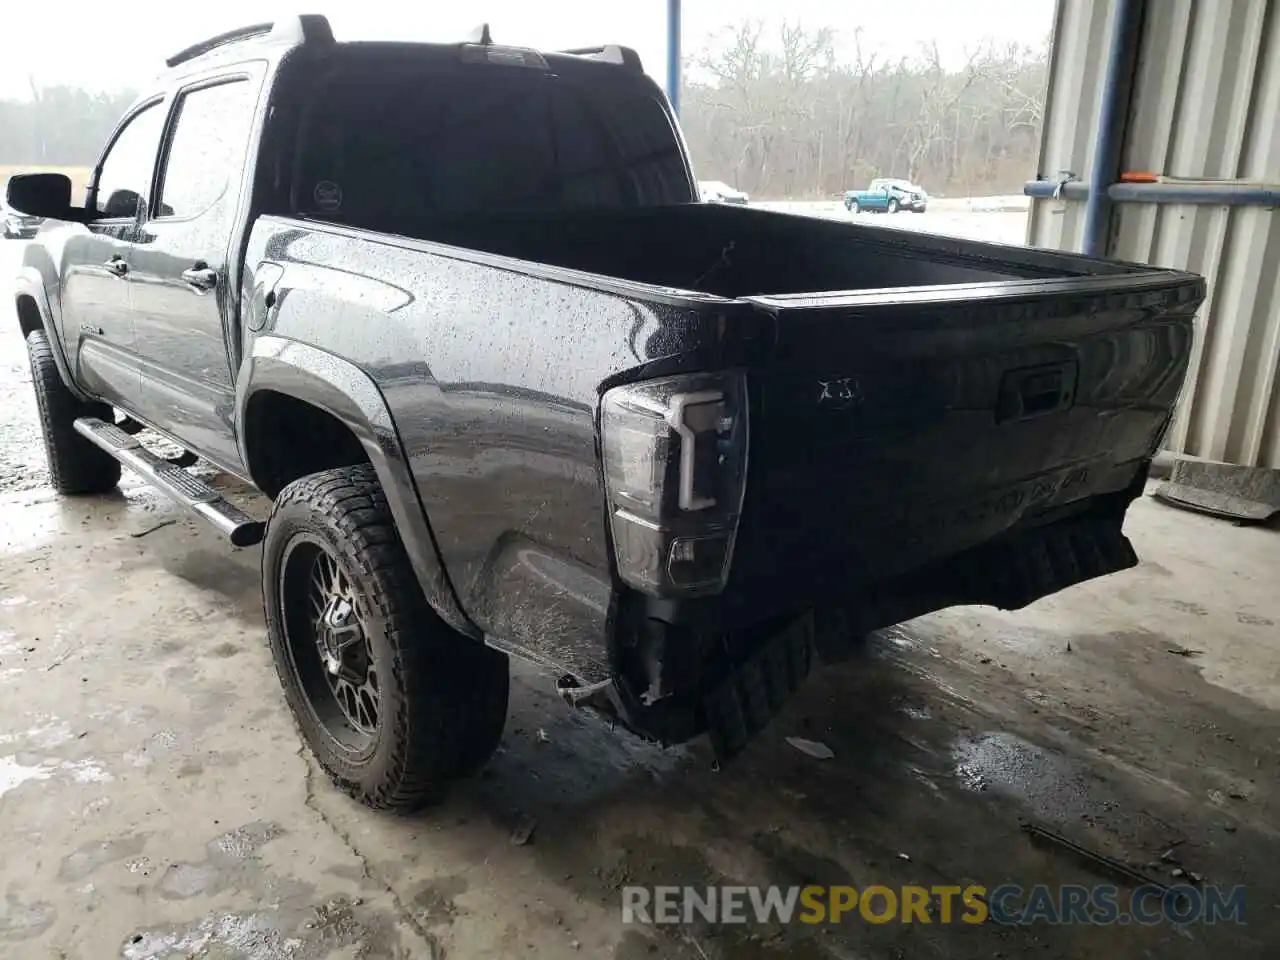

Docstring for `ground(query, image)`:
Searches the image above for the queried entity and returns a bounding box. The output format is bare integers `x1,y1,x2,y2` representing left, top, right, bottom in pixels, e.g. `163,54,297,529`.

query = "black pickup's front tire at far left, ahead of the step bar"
27,330,120,495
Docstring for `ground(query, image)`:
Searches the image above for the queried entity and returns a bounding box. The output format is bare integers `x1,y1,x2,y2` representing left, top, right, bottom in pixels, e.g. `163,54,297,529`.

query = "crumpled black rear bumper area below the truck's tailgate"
608,470,1146,760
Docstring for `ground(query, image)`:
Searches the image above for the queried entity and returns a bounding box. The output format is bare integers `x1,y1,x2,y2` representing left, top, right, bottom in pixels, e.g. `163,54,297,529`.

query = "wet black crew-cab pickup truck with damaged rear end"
9,17,1204,808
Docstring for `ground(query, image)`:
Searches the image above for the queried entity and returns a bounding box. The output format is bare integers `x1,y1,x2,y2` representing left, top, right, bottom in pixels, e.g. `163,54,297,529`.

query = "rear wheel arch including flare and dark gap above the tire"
236,335,481,637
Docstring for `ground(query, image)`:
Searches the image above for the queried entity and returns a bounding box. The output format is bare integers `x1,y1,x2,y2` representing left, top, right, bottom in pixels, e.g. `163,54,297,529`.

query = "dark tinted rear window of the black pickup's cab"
293,68,694,224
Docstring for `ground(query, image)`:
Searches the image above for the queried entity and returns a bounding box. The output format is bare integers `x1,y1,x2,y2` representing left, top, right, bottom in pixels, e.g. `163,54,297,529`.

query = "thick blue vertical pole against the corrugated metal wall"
1084,0,1146,257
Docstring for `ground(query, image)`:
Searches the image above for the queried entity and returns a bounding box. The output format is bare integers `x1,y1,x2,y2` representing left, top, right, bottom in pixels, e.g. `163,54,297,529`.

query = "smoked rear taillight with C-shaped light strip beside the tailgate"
600,372,748,596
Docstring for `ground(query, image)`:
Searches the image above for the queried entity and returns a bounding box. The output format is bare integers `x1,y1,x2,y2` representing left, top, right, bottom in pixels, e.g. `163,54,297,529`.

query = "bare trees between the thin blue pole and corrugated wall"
681,22,1048,200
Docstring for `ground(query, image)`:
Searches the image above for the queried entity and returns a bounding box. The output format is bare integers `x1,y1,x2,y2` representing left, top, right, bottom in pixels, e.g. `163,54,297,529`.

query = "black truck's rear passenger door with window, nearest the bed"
129,74,261,470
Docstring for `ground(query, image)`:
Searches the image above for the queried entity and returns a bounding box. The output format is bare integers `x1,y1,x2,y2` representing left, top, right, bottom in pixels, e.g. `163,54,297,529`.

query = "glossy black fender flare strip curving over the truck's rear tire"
236,334,484,639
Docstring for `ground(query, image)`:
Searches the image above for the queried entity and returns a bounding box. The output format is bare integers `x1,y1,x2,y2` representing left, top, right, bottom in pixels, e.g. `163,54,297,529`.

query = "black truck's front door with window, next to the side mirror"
61,100,165,410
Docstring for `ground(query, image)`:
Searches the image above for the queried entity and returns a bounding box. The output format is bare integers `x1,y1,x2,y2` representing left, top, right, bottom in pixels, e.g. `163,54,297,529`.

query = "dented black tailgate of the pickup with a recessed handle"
726,270,1204,616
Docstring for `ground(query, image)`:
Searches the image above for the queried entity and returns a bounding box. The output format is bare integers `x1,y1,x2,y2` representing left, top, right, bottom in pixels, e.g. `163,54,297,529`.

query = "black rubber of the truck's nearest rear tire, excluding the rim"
262,465,511,813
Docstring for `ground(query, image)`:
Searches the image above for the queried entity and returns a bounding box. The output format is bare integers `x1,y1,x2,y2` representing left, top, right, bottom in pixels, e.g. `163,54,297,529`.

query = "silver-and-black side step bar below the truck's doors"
76,417,266,547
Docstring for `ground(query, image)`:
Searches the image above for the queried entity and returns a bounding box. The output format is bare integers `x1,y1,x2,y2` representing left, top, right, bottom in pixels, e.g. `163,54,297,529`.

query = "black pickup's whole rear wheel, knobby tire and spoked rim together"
262,465,509,810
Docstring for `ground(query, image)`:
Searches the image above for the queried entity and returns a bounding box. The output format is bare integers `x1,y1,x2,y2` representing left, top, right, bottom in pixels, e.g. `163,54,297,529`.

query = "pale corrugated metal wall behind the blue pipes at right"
1028,0,1280,468
